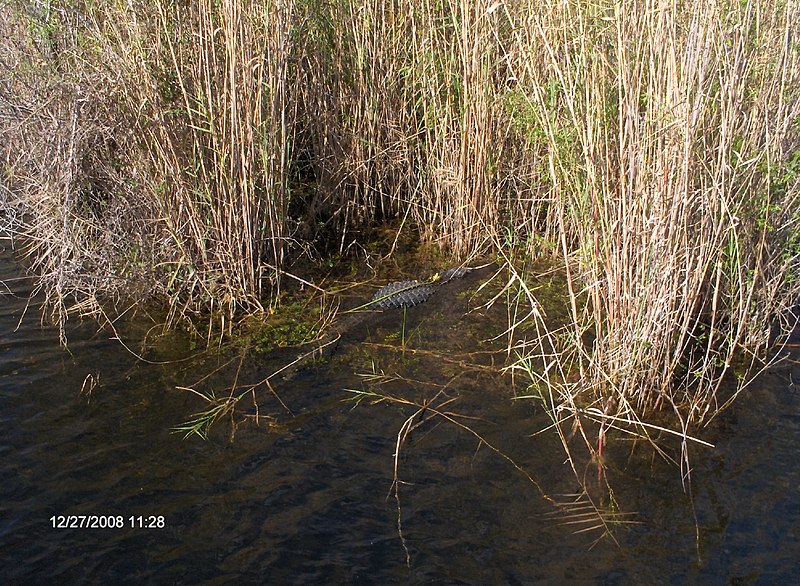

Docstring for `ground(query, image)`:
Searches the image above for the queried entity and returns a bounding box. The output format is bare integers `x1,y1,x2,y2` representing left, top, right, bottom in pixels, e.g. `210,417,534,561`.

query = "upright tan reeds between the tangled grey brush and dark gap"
96,0,293,318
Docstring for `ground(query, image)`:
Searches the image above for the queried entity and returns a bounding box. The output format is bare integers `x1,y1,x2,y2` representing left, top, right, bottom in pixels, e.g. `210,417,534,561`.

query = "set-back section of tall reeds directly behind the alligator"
294,0,506,256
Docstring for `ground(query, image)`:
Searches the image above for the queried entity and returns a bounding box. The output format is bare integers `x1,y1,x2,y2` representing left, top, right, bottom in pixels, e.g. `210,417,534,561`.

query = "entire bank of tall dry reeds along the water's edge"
0,0,800,484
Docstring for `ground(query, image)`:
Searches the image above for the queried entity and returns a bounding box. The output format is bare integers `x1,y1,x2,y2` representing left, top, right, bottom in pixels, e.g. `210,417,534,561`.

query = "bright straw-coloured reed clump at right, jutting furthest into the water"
500,1,800,480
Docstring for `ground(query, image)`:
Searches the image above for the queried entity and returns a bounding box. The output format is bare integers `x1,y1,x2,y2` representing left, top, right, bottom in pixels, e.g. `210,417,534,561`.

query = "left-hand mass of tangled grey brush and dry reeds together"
0,1,293,336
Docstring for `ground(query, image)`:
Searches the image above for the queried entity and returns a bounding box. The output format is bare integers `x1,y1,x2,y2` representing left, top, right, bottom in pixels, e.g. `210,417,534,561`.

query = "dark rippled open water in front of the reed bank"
0,240,800,584
